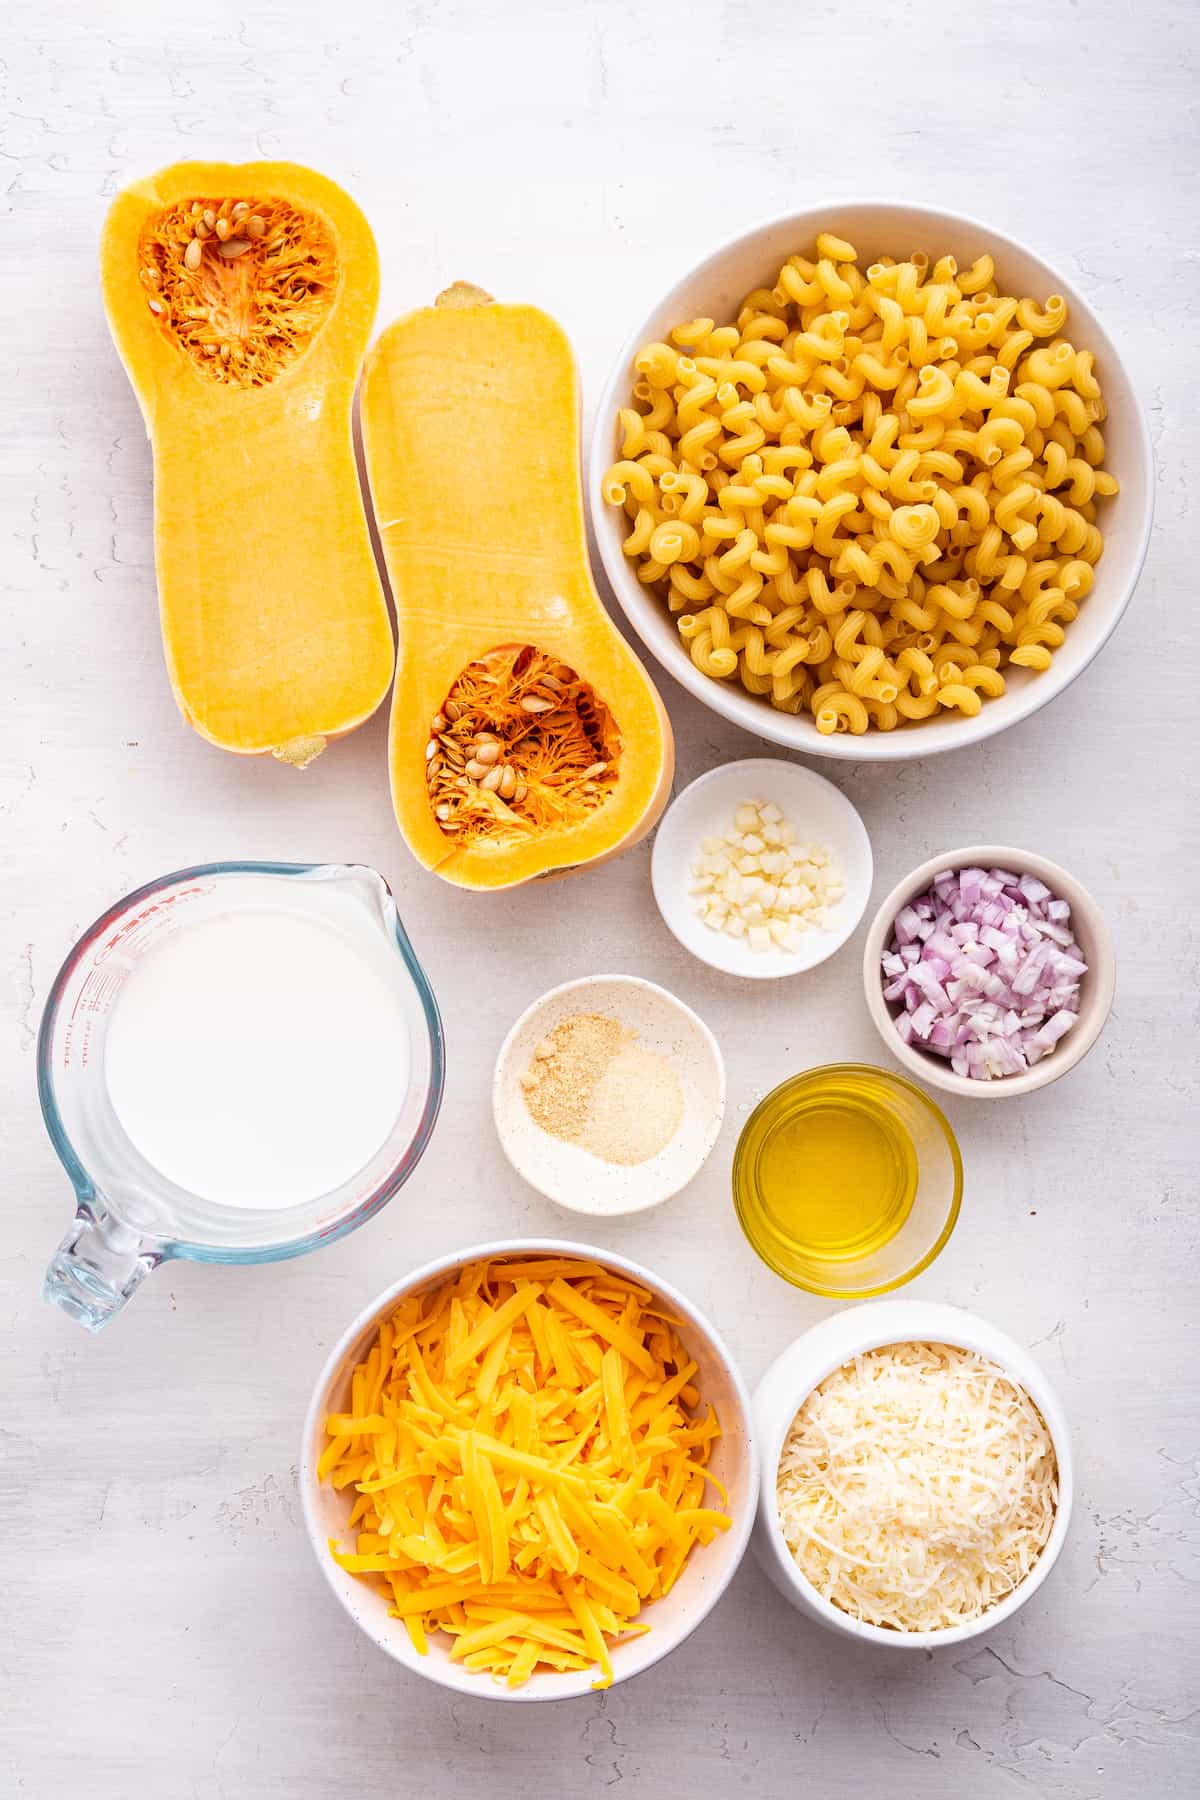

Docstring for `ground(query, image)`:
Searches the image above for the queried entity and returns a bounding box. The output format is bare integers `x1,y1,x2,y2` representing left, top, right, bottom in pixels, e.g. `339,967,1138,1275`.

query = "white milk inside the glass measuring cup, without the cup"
104,907,408,1208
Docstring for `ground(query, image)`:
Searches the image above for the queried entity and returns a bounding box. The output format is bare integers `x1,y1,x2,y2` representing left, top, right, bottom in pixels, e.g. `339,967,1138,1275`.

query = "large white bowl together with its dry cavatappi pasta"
588,202,1153,761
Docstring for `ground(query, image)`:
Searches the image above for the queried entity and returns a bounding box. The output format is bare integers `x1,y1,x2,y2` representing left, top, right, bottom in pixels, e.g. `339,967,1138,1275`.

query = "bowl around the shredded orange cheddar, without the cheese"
299,1238,759,1701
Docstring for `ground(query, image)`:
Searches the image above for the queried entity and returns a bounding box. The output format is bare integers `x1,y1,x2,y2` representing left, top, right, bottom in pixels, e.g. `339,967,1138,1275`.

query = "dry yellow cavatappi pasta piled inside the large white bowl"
604,232,1117,734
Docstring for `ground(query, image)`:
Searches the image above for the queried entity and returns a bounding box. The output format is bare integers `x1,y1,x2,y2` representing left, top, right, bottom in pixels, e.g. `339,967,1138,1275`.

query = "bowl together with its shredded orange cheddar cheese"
300,1238,757,1701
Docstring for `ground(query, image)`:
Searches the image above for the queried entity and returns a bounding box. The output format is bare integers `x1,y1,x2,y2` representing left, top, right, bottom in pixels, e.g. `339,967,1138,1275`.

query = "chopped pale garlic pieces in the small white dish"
691,799,844,950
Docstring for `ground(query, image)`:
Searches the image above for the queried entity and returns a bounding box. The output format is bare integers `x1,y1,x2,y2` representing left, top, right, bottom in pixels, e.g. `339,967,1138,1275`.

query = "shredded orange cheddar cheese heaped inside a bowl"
318,1256,730,1687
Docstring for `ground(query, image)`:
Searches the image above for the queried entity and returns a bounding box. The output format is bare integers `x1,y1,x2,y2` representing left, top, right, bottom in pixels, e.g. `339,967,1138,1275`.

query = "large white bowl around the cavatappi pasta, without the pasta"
587,200,1153,763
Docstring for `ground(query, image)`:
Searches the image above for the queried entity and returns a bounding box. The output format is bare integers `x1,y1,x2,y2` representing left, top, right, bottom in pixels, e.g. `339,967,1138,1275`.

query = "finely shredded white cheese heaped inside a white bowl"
777,1343,1058,1631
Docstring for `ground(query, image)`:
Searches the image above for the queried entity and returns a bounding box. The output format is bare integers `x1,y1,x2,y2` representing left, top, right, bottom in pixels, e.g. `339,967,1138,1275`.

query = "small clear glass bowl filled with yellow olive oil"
734,1062,963,1300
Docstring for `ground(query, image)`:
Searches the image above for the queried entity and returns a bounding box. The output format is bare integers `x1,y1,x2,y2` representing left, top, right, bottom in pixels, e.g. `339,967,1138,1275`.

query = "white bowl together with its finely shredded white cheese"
754,1300,1072,1649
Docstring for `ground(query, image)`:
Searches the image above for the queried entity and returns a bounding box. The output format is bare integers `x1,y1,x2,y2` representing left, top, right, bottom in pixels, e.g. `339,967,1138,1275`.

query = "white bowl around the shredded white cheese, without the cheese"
752,1300,1074,1651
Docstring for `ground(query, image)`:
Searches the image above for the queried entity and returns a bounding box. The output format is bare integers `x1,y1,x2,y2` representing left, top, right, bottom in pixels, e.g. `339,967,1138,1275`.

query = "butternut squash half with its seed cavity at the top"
101,162,392,765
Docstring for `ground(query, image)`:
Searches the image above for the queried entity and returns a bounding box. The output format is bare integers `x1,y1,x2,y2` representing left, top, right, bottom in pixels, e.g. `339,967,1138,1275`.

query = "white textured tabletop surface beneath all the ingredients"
0,0,1200,1800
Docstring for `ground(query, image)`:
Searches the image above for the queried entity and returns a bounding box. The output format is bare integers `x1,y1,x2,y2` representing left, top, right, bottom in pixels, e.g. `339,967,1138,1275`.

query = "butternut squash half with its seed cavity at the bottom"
362,284,673,887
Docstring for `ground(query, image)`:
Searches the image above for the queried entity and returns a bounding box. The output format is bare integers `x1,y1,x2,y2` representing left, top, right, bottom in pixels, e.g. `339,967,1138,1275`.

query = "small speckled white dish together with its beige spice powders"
491,976,725,1215
